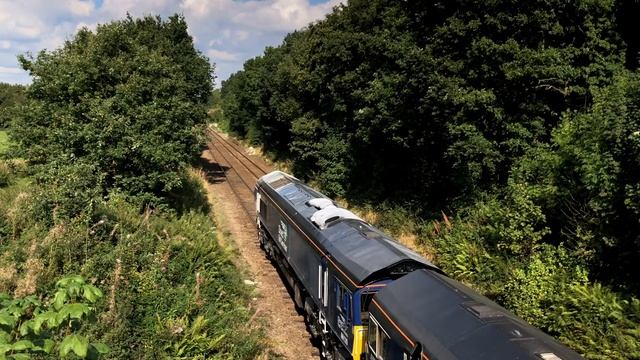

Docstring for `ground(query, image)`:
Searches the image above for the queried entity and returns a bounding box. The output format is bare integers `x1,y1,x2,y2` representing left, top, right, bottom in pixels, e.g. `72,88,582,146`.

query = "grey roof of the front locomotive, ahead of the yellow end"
259,172,437,286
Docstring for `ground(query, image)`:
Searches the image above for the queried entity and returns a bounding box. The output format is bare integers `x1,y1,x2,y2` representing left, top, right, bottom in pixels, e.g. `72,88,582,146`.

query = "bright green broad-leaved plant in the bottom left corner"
0,276,109,360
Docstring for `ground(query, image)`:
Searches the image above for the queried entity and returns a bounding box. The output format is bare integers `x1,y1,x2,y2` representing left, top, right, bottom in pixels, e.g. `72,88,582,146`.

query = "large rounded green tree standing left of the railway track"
12,15,212,207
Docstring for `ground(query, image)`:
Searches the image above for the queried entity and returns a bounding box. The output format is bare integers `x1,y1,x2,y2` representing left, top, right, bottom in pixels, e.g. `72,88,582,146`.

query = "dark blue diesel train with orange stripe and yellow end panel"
255,171,581,360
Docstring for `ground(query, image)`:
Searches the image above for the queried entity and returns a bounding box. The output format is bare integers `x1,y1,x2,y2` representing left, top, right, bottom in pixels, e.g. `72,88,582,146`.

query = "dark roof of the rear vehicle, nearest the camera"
370,270,581,360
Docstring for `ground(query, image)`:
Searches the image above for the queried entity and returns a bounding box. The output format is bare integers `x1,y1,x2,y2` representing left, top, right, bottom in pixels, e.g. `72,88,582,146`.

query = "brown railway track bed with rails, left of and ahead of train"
202,129,319,359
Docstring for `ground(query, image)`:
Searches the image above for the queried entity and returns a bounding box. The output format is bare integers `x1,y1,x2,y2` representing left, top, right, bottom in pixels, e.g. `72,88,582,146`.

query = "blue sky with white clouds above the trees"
0,0,342,86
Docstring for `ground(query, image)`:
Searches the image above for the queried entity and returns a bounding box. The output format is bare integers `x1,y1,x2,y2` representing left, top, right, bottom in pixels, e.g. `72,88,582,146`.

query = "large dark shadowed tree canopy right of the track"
222,0,624,205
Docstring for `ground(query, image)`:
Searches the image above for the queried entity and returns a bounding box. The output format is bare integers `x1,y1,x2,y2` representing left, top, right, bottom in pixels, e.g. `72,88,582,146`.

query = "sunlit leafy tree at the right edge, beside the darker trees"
511,71,640,293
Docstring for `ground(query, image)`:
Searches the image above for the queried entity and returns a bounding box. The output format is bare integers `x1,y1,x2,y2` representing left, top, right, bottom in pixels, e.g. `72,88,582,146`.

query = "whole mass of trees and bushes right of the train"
221,0,640,358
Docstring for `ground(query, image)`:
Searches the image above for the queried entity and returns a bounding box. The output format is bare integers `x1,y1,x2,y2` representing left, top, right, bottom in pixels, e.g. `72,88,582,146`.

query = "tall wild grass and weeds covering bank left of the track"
0,170,264,359
